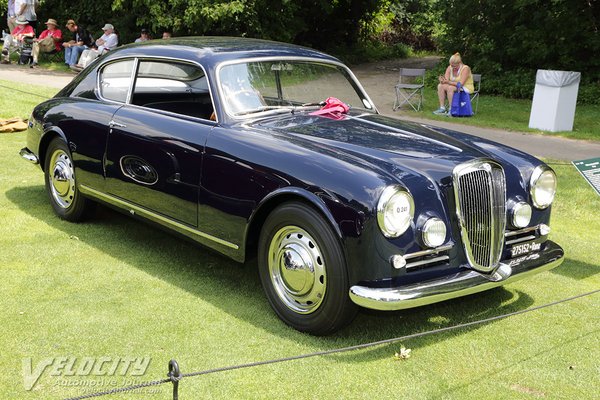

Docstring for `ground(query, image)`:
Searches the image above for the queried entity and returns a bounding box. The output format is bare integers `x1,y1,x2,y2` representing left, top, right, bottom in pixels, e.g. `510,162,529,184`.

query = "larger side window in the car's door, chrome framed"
131,60,214,119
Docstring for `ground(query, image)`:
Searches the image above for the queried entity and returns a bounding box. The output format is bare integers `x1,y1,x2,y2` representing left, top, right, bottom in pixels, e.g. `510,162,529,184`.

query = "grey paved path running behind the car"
0,57,600,161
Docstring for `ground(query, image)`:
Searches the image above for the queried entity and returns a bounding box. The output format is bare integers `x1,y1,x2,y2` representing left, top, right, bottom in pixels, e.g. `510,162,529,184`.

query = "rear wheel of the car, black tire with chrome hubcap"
44,137,95,222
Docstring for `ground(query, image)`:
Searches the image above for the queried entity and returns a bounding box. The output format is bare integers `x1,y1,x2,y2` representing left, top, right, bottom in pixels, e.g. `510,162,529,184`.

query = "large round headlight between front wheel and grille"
377,186,415,237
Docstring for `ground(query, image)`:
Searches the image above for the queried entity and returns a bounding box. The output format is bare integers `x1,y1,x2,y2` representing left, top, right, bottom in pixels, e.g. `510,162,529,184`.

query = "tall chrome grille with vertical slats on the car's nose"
453,160,506,272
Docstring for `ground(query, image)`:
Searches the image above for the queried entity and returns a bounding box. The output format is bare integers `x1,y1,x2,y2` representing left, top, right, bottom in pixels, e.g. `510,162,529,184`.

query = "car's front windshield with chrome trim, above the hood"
219,60,373,117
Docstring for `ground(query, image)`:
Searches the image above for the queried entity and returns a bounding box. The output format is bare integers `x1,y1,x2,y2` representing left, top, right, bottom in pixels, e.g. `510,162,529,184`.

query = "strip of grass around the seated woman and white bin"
402,85,600,141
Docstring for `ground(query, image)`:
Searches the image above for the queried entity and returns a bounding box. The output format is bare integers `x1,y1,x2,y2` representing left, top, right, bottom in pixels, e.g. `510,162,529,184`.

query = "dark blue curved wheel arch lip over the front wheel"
245,187,347,259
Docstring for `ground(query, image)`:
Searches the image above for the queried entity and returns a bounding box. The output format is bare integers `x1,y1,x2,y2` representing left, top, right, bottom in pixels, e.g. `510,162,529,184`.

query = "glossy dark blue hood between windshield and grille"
254,114,490,181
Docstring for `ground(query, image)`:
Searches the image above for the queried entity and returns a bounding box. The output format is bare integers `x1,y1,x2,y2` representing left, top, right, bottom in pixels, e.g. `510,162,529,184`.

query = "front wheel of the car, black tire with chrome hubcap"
258,202,358,335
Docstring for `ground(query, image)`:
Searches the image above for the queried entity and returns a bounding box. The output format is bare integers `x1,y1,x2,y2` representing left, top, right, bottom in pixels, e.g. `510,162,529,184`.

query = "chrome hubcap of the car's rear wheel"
48,150,75,208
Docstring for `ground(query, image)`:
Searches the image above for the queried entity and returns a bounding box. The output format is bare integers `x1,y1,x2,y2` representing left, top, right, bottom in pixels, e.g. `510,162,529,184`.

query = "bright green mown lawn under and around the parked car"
0,83,600,400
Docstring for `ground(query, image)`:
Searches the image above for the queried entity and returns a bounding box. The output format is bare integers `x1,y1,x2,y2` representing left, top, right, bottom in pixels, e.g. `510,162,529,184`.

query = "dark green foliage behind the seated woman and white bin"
437,0,600,97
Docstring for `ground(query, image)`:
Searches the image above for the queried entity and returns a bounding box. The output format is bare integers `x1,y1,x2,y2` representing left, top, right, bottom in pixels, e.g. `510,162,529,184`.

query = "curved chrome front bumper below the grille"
350,241,564,310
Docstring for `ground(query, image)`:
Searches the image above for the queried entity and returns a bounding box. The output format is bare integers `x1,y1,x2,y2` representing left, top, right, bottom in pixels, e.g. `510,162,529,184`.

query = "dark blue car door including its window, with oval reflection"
105,59,215,227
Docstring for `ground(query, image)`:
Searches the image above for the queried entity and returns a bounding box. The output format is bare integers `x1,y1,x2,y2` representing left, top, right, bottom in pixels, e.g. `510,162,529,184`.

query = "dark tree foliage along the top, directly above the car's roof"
32,0,380,49
